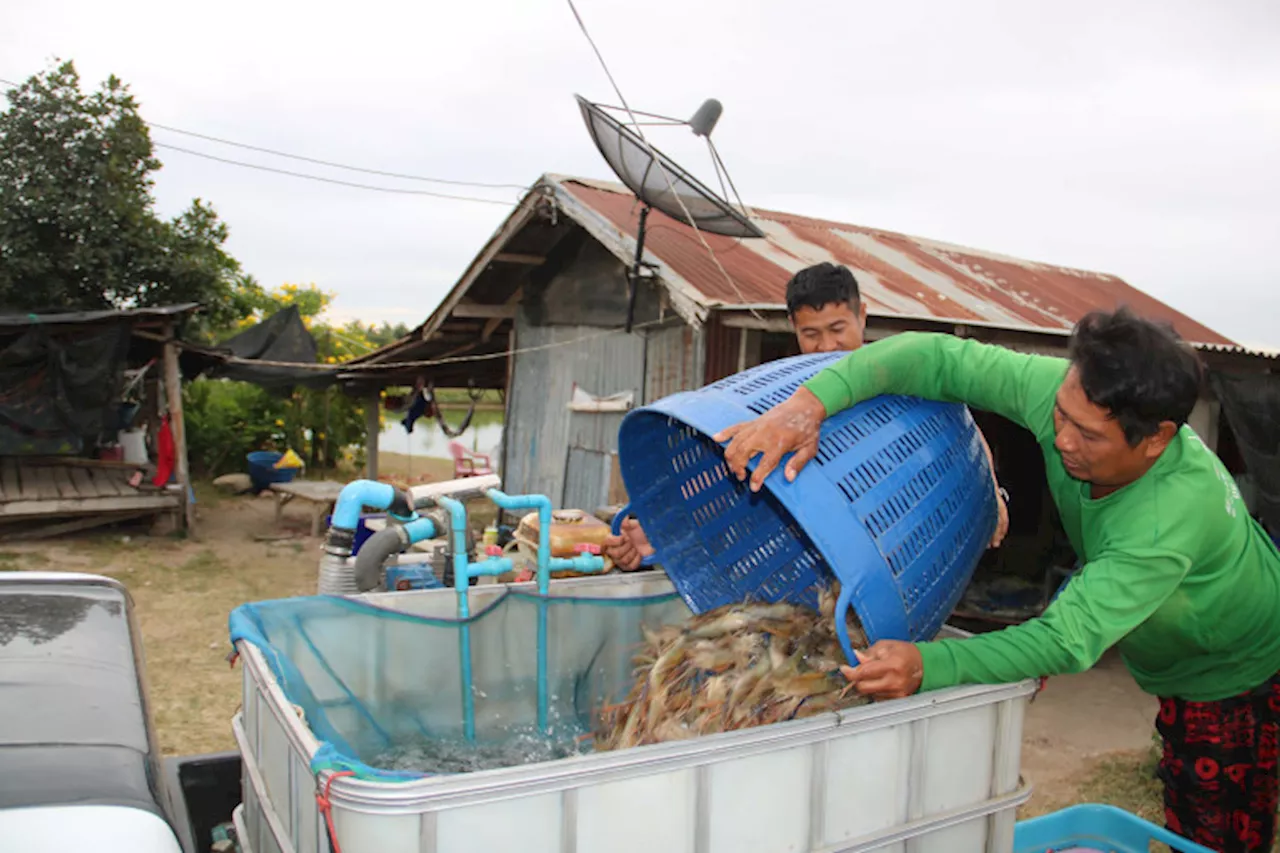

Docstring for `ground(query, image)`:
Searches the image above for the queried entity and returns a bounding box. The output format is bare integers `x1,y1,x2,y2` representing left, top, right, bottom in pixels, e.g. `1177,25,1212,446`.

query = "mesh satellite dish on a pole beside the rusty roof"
575,95,764,332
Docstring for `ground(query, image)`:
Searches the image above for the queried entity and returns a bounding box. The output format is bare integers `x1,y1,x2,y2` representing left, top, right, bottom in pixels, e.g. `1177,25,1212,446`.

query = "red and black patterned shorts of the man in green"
1156,672,1280,853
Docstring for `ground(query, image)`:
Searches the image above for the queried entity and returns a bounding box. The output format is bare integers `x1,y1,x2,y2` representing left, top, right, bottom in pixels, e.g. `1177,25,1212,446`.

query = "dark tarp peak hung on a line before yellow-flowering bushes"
200,305,338,393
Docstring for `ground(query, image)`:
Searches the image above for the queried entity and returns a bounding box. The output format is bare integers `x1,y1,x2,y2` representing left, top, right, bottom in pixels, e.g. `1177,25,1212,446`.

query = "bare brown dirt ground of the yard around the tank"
0,479,1158,817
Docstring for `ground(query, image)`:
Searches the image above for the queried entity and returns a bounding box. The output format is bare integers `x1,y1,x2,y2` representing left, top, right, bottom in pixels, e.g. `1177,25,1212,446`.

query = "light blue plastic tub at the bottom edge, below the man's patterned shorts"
1014,804,1213,853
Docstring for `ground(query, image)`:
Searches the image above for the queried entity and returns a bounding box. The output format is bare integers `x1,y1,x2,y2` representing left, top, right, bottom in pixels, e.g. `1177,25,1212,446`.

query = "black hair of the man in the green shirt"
1070,307,1203,447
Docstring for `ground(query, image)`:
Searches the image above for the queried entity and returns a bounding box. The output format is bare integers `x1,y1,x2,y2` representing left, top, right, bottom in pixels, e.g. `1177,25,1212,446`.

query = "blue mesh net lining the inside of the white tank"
229,590,689,780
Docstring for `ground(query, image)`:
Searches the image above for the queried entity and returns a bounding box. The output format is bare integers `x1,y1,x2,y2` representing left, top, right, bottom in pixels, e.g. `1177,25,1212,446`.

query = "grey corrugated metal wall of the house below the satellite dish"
503,313,704,511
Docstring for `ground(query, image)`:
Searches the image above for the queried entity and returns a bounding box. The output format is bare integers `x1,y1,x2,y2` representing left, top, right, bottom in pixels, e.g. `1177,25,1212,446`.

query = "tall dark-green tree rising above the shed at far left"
0,61,239,315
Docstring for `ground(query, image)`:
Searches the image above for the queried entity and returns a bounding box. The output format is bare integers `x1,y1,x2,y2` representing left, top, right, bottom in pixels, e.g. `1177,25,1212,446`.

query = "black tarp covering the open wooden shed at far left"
0,315,133,456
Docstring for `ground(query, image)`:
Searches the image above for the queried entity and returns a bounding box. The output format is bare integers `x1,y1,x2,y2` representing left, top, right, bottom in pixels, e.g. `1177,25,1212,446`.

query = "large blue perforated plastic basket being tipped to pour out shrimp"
618,353,996,660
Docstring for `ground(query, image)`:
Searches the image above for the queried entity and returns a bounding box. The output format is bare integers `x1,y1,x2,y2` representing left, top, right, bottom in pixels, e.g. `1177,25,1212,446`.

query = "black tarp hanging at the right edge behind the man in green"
1210,370,1280,533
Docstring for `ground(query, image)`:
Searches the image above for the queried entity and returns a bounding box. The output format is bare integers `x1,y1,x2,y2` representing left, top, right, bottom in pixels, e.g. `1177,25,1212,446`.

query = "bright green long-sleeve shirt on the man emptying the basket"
805,333,1280,702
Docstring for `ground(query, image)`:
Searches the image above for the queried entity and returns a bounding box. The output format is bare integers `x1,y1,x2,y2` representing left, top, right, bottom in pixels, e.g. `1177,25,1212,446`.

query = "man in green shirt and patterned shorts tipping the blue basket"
716,310,1280,850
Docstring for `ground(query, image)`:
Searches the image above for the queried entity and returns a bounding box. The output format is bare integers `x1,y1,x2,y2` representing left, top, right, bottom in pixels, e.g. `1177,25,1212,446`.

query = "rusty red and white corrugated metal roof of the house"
555,175,1234,346
